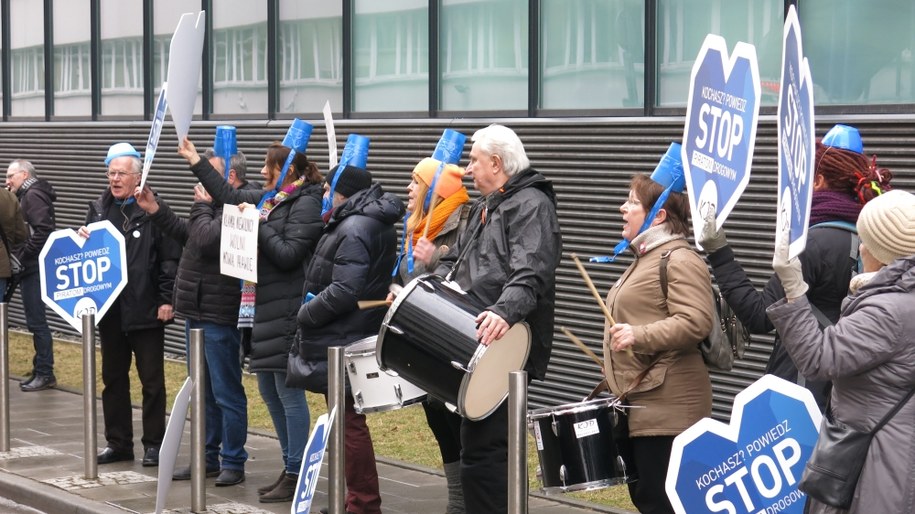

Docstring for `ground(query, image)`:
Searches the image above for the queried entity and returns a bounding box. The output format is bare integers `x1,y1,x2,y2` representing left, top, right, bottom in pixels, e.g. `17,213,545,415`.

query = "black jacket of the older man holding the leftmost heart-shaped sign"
86,189,181,332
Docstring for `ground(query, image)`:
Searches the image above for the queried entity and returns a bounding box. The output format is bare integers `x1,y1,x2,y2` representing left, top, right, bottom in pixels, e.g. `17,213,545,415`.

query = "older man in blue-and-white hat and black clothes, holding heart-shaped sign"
79,143,181,466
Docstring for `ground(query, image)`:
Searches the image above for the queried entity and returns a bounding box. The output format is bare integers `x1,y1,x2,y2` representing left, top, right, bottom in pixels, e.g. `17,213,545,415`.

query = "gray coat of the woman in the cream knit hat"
767,256,915,514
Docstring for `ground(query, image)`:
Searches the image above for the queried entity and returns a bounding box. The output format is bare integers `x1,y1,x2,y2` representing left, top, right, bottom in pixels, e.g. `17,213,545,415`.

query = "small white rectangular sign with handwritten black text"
219,205,260,282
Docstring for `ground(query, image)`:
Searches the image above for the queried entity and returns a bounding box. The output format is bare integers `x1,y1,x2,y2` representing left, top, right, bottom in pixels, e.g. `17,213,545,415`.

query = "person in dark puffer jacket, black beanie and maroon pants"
295,166,404,514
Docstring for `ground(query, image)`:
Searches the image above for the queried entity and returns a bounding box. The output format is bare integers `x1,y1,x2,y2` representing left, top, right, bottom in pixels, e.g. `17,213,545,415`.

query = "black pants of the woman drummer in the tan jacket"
629,436,674,514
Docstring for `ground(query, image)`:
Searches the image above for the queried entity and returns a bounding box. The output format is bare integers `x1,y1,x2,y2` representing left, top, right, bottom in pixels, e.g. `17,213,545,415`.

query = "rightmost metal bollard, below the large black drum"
508,371,528,514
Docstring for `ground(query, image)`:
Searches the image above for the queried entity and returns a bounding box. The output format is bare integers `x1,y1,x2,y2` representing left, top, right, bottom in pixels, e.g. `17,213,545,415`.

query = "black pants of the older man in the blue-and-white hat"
98,309,165,451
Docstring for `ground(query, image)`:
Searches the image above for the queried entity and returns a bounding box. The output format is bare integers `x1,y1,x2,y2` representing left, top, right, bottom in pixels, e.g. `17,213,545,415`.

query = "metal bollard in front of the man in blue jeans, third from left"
190,328,207,512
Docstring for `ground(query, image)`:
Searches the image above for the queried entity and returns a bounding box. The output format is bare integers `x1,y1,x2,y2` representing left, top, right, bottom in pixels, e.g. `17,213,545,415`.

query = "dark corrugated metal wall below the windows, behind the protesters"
0,116,915,418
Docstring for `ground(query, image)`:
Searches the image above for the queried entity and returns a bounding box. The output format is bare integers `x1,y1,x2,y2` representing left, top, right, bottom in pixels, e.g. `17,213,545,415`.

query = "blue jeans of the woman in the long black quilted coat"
257,371,311,475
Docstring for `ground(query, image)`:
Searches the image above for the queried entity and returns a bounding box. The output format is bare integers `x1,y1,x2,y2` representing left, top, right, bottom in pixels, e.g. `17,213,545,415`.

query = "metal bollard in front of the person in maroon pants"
327,346,346,514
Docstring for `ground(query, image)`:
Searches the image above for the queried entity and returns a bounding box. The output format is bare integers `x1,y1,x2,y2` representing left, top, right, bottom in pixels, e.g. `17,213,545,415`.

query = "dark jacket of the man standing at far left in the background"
14,178,57,274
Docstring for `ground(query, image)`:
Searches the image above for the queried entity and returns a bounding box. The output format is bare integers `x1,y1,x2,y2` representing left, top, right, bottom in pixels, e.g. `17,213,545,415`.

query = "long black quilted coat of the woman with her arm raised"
191,159,323,373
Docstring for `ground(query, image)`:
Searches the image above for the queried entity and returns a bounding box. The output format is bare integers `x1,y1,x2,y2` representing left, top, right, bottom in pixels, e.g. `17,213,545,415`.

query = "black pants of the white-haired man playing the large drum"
461,401,508,514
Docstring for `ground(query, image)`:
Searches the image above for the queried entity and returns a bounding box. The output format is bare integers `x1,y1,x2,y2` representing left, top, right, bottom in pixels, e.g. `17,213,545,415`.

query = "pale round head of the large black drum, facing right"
458,322,531,421
